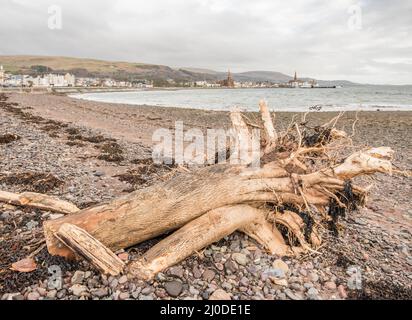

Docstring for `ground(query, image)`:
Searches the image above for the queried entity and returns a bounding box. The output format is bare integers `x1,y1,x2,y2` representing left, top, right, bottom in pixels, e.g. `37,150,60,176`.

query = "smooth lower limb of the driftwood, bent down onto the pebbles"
128,205,286,280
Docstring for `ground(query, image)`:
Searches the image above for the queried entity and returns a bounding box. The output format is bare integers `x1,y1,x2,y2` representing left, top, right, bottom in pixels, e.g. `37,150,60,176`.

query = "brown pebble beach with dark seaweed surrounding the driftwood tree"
0,93,412,300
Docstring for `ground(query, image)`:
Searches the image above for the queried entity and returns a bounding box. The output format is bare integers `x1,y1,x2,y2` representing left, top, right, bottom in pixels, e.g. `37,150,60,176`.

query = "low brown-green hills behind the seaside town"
0,56,355,85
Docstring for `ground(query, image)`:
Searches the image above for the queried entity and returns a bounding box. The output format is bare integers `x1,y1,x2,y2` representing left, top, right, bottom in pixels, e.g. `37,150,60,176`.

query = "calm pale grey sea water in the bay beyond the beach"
72,86,412,111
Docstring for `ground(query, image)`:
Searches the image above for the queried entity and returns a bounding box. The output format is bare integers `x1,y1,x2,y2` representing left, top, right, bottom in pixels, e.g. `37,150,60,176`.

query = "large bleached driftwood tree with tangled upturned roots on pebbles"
36,102,400,279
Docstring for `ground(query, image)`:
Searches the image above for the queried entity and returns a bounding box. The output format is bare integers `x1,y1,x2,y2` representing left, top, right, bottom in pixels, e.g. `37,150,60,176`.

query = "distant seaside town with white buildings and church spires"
0,66,326,89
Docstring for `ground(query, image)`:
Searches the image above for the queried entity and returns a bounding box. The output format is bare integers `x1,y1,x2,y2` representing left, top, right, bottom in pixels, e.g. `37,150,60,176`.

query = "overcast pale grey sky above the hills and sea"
0,0,412,84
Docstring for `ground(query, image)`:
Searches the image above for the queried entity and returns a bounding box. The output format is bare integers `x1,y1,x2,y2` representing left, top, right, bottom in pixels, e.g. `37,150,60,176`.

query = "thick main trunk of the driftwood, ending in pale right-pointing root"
44,148,392,257
